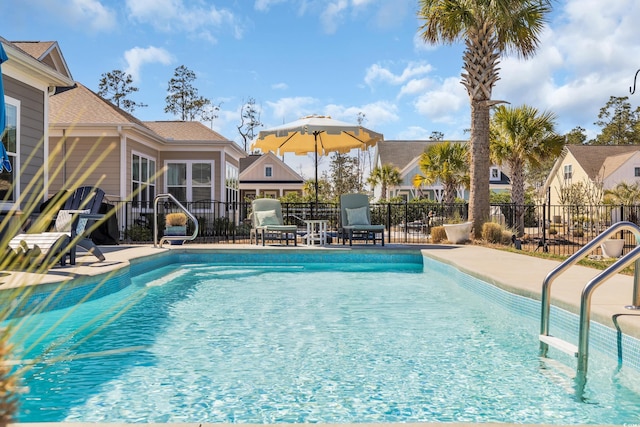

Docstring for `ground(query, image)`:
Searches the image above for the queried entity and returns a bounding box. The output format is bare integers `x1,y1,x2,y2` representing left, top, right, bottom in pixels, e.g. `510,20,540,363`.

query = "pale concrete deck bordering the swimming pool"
0,244,640,427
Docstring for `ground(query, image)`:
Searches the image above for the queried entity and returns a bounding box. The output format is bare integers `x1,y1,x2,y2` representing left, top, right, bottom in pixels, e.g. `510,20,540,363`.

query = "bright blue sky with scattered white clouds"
0,0,640,178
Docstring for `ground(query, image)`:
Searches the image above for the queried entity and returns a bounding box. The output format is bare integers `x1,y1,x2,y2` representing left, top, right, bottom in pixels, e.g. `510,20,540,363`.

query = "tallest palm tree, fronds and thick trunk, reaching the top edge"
418,0,551,236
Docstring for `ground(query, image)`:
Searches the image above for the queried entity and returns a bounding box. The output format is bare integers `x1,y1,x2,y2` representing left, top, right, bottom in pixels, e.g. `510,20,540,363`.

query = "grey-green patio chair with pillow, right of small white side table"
340,194,384,246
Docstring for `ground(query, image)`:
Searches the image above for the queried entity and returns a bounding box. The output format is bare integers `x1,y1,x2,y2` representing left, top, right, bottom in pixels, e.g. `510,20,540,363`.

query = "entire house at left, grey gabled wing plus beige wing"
0,39,247,241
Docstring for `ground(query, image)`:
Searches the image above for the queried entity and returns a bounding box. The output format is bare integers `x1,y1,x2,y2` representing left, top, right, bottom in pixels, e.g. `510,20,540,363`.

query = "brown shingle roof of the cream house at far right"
565,145,640,179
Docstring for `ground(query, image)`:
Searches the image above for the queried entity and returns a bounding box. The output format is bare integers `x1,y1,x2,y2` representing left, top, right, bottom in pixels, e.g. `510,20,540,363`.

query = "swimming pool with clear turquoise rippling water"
6,253,640,424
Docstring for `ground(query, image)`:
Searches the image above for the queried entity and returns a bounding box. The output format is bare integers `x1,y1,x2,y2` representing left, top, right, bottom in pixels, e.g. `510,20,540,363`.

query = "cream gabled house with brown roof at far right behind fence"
545,145,640,205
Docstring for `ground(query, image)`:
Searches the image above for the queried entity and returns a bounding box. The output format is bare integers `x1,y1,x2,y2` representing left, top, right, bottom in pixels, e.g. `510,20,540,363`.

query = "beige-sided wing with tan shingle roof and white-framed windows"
49,84,246,206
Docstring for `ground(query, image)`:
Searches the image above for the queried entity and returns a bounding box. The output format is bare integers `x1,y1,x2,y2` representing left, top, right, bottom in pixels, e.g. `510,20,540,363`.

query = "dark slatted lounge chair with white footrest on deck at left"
9,187,105,265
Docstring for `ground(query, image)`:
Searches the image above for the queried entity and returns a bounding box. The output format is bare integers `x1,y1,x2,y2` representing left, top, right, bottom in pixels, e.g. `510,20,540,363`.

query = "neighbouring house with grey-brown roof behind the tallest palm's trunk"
373,140,511,201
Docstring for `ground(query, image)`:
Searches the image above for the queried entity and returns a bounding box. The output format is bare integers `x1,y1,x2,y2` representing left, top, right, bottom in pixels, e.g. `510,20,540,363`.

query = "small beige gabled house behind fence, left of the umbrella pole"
240,152,304,200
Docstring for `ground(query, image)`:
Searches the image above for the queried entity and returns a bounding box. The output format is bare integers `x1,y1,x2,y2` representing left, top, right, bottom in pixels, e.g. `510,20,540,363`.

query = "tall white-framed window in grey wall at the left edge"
0,100,20,208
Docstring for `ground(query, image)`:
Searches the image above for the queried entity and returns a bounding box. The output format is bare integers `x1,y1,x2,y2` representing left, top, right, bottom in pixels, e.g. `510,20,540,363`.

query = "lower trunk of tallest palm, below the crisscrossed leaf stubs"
469,99,491,238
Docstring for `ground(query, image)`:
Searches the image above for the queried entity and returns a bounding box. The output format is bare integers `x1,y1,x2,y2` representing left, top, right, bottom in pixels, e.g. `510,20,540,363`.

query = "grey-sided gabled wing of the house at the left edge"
0,37,73,239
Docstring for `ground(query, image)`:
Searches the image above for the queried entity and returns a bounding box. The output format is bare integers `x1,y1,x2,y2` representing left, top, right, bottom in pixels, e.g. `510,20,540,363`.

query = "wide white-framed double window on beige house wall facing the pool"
166,160,214,202
